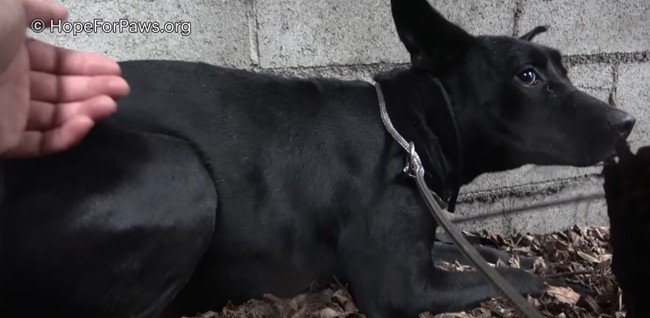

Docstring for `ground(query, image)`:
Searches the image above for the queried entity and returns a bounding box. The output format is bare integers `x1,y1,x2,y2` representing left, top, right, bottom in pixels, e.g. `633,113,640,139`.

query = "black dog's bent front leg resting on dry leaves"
340,190,542,318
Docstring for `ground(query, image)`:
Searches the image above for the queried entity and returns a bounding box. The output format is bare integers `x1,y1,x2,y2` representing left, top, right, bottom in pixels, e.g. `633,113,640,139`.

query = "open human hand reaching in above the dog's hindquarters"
0,0,129,157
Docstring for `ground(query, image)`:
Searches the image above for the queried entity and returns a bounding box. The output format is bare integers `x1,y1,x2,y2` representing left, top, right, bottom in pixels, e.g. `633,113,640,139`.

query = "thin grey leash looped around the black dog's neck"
375,78,543,318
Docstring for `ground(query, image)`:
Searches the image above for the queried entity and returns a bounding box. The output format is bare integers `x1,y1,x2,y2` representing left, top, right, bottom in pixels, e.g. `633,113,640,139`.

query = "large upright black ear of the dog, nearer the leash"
391,0,474,72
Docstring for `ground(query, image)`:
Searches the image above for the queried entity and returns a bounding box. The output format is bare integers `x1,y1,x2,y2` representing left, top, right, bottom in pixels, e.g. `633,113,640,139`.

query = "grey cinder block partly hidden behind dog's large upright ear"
256,0,514,68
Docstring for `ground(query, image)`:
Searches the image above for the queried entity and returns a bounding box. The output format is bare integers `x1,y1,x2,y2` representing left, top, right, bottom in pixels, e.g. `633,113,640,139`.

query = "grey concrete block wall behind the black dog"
32,0,650,233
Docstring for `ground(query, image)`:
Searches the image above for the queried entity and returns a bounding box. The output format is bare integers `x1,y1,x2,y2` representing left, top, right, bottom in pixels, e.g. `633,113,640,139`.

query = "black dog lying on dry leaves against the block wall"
0,0,634,317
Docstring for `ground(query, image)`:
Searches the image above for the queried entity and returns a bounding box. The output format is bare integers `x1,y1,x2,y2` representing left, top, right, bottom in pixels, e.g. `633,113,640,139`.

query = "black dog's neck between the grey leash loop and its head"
375,69,463,210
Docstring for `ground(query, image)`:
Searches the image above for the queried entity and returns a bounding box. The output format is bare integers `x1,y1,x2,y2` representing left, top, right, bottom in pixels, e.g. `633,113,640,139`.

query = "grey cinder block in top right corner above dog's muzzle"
518,0,650,55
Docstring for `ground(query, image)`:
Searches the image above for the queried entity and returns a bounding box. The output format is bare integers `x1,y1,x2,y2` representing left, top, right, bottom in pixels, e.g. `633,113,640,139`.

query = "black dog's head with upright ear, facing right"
392,0,635,173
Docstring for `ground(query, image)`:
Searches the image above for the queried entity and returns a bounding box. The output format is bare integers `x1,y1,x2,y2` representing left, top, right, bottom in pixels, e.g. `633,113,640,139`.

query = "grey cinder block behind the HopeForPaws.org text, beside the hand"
30,0,251,67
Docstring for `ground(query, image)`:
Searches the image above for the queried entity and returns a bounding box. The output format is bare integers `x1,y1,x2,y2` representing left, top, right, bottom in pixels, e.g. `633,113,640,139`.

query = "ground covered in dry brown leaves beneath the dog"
182,227,625,318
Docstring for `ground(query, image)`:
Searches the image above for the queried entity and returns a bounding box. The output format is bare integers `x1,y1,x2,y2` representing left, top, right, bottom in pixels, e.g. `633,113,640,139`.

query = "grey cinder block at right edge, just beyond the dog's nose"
616,62,650,150
